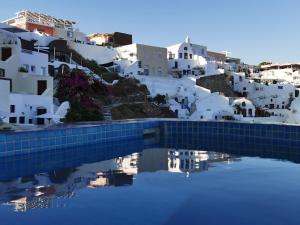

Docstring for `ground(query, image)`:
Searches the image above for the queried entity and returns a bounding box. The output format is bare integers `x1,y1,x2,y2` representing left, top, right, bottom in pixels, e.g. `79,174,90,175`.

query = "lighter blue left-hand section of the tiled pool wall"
0,121,159,156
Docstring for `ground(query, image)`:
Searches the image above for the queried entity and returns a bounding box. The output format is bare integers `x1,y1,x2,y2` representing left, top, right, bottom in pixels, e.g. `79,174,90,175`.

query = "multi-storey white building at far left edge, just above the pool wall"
0,29,68,124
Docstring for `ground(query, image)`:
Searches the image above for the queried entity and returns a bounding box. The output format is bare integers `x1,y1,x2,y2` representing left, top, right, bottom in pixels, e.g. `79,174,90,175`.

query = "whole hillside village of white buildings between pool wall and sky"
0,11,300,127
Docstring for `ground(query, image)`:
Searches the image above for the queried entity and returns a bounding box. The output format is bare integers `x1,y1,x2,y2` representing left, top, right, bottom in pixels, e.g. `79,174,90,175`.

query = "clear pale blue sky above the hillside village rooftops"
0,0,300,64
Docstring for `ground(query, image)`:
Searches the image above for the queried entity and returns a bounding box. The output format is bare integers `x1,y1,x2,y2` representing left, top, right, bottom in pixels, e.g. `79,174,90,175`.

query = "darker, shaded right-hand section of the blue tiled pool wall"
161,121,300,153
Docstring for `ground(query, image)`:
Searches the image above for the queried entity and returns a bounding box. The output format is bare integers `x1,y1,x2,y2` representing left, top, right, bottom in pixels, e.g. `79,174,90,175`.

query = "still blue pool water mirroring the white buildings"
0,140,300,225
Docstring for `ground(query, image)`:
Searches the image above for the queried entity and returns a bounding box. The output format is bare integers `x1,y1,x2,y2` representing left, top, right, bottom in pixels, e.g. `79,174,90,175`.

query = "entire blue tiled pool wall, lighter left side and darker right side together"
0,120,300,156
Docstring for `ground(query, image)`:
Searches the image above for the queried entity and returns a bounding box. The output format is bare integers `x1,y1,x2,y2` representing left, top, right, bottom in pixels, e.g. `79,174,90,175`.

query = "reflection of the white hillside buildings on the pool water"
0,149,237,211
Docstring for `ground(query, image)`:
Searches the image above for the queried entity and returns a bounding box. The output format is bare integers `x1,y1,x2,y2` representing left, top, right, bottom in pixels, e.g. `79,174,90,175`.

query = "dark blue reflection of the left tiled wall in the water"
0,138,149,181
